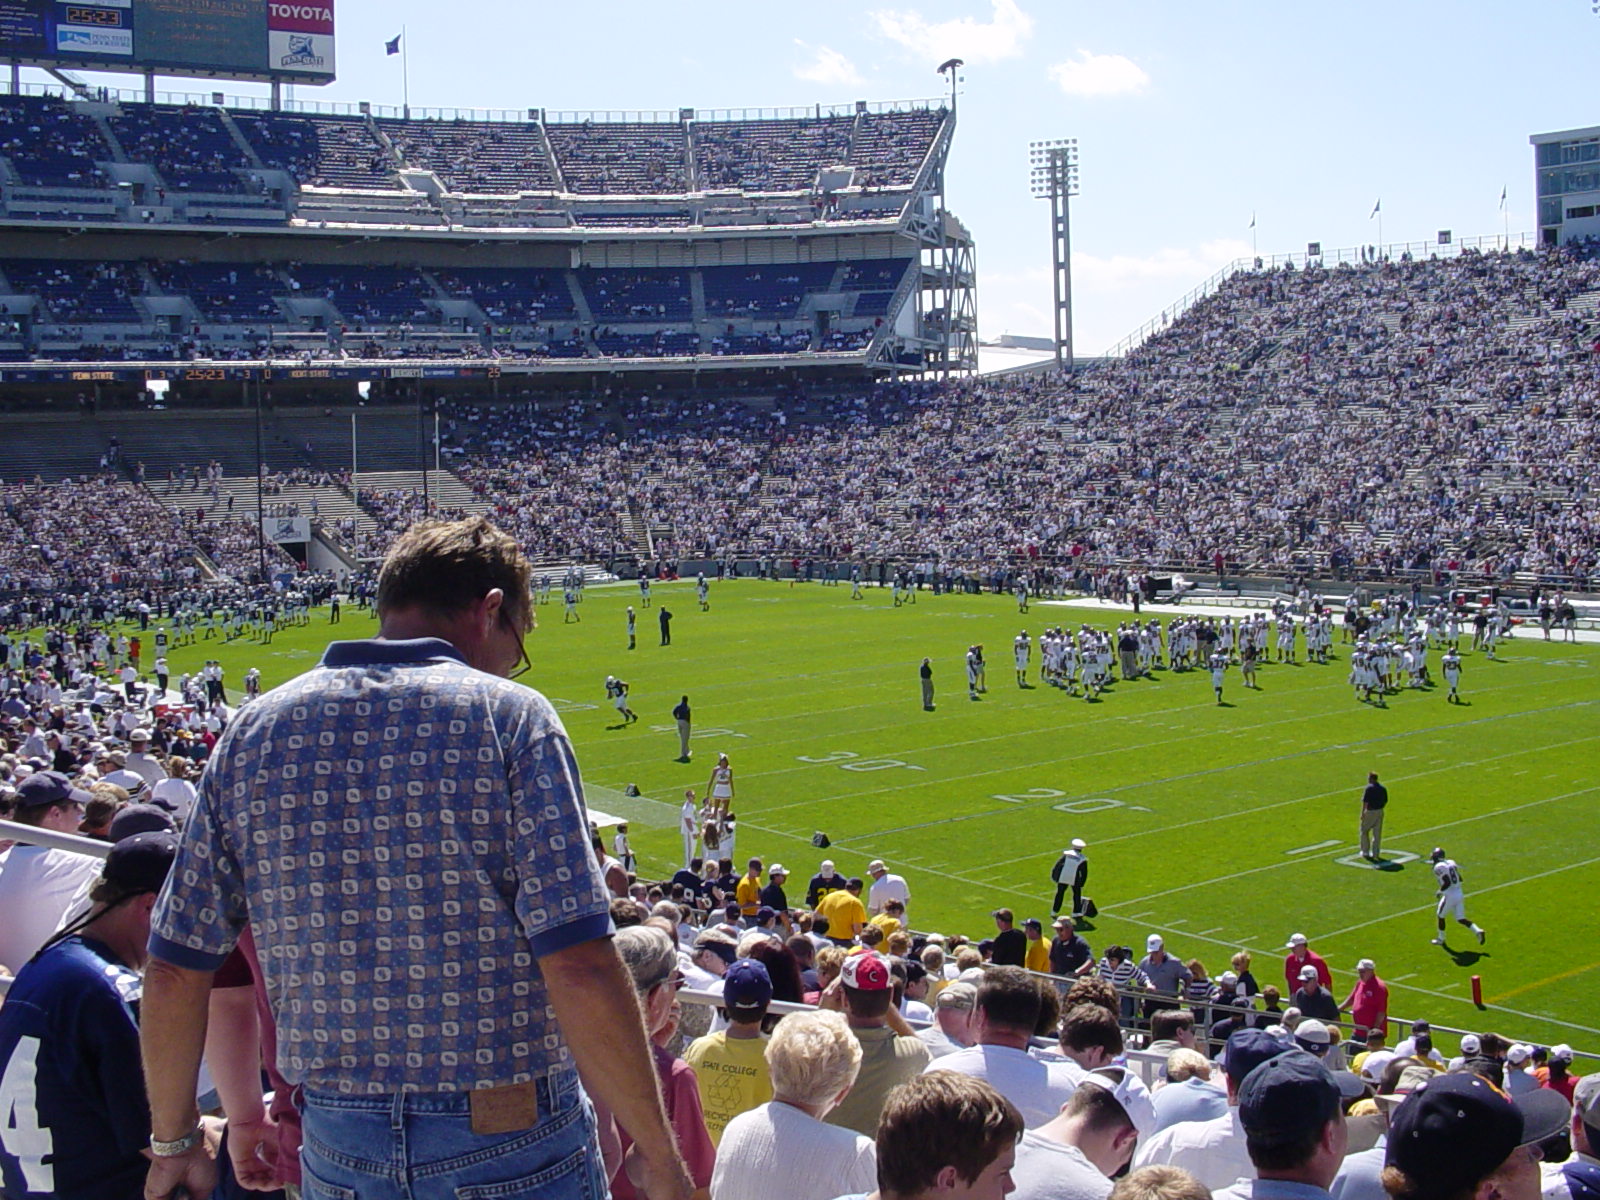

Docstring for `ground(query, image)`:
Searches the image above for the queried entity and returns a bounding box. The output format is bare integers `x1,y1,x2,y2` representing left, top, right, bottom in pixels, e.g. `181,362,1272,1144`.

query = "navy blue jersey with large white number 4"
0,938,150,1200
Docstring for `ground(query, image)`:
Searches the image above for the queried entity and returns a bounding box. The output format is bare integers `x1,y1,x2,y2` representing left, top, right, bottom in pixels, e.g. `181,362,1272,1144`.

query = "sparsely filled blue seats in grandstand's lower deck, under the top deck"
0,259,889,362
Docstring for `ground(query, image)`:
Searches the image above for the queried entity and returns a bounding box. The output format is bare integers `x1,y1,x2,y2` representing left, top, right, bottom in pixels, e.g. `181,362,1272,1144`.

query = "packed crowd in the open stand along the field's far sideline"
406,251,1600,578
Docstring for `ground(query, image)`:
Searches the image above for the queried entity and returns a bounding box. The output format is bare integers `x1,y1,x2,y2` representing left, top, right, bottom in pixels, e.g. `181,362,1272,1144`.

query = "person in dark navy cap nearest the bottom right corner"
1382,1074,1570,1200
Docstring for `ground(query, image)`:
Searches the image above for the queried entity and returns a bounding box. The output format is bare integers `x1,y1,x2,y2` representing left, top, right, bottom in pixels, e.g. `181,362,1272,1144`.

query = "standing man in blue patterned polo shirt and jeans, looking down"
142,517,690,1200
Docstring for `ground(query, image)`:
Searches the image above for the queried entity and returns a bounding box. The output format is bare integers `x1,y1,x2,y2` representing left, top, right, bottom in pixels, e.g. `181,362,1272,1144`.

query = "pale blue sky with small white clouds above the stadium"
29,0,1600,355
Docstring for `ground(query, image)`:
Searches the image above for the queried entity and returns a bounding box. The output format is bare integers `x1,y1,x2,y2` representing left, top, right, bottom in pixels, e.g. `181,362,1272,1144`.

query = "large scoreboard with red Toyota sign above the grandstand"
0,0,334,83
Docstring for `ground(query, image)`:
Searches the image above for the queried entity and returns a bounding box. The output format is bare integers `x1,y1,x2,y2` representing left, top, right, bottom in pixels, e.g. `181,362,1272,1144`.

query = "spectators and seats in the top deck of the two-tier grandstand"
0,96,946,202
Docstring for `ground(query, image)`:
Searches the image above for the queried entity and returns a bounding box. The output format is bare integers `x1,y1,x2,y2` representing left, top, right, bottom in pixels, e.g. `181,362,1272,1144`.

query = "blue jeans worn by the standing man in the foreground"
301,1074,610,1200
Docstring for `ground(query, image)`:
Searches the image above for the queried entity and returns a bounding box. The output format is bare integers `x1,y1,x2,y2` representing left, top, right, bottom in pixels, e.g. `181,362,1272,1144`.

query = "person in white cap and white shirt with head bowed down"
1011,1067,1155,1200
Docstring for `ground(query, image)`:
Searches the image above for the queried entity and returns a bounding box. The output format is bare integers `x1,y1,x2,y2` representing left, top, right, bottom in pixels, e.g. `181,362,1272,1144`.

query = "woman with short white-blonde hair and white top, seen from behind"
710,1011,877,1200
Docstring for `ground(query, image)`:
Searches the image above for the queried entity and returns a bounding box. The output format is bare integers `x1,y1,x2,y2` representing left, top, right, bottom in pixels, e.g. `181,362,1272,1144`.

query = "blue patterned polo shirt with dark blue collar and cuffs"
150,638,613,1093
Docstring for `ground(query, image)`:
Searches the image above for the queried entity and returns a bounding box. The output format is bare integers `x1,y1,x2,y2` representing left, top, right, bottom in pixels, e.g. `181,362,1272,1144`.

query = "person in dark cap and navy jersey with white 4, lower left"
0,832,178,1200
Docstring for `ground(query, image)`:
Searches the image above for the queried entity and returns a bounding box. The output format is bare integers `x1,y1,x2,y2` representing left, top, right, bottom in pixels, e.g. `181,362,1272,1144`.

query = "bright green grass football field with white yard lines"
156,581,1600,1051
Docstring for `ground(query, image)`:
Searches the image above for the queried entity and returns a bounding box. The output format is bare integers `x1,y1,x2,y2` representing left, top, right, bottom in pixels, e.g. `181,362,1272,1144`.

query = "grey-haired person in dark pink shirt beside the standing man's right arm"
611,925,717,1200
